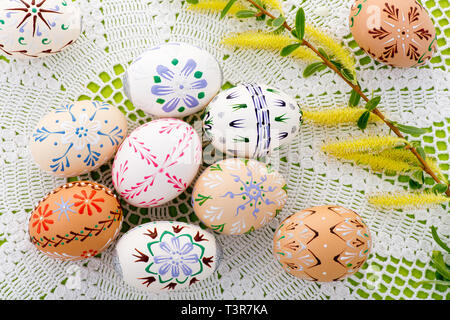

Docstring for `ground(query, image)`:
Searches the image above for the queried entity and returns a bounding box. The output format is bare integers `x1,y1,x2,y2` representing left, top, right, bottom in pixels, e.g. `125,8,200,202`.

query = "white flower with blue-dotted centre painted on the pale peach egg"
61,113,101,150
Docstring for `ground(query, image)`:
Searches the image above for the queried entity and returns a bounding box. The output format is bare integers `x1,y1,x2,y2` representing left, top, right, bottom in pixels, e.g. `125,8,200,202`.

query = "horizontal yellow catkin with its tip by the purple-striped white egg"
303,107,381,125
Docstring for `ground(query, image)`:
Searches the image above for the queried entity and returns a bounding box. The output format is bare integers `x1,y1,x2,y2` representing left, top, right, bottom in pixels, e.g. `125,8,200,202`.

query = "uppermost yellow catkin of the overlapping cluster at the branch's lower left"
328,153,419,173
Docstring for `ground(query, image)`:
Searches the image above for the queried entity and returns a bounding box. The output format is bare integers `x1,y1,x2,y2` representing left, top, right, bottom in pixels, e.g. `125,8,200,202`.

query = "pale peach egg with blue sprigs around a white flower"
29,101,127,177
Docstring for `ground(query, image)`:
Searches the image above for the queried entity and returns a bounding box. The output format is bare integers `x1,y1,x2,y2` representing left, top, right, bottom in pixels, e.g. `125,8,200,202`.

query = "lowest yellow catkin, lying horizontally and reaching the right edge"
368,192,450,208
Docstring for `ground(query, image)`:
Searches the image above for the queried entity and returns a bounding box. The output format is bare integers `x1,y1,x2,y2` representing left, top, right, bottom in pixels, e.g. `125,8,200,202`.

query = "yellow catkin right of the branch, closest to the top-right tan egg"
305,24,356,73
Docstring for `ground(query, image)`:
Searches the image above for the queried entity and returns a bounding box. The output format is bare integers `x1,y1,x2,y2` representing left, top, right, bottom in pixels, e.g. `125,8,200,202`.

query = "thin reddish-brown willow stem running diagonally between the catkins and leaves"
246,0,450,197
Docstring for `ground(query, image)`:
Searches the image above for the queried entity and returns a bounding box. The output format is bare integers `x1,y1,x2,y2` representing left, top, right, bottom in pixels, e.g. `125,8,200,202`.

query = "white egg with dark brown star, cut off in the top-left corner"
0,0,81,58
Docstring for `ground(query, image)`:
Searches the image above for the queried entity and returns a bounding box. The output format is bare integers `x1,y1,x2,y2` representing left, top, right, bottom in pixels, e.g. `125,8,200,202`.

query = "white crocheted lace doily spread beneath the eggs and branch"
0,0,450,300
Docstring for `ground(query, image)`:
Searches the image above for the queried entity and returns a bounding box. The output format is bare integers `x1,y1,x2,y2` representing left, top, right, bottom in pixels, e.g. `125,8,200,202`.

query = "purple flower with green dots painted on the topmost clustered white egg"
151,59,208,112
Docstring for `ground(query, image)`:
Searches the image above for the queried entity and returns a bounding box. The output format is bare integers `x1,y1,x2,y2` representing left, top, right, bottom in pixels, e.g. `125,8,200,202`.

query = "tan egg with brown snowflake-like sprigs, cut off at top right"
349,0,437,68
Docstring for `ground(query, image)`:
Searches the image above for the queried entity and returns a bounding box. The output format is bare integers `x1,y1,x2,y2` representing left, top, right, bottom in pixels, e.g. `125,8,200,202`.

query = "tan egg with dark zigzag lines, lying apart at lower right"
273,205,371,282
